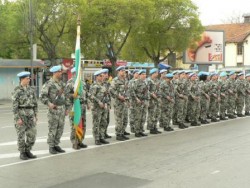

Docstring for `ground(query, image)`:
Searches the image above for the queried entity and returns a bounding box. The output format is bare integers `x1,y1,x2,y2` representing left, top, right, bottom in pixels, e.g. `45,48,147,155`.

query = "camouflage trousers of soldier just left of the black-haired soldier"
188,100,201,123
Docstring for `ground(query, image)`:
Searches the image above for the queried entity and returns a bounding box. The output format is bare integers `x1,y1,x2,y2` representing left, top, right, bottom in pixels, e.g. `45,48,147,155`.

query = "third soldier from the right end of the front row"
227,71,237,119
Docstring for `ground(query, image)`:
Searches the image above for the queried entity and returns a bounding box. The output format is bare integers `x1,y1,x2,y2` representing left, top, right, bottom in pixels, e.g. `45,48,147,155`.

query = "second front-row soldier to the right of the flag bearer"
110,66,129,141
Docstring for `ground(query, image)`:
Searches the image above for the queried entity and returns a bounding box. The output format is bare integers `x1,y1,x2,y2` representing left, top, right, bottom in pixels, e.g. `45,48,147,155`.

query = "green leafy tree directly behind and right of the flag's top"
82,0,150,72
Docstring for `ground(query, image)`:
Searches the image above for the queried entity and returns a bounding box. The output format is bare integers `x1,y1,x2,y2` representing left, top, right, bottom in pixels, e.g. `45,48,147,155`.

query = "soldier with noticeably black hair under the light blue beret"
198,72,210,124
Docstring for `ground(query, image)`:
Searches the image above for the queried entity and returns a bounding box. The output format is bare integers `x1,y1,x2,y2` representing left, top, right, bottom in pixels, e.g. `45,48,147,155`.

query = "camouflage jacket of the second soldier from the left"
40,78,66,106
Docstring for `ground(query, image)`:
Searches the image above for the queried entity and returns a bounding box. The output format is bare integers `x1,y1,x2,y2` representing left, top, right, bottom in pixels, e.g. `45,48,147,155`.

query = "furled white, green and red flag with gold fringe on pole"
73,19,85,141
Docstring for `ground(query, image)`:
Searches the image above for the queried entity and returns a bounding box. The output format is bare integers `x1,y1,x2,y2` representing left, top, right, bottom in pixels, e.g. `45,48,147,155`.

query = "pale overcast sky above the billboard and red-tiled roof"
192,0,250,25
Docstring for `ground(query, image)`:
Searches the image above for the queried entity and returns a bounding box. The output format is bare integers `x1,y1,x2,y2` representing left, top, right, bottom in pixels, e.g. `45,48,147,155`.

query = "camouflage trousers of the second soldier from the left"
47,106,65,147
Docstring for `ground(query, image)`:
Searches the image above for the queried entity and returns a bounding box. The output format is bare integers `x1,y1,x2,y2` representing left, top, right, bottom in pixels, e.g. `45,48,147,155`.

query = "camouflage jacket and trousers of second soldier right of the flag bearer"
110,77,128,137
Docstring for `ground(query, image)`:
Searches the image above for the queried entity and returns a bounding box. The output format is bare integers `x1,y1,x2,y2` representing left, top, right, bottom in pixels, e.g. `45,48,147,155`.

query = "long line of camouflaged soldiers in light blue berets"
12,66,250,160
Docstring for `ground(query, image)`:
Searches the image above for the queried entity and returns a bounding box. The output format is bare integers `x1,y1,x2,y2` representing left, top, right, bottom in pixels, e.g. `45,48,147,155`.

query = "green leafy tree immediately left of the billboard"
125,0,204,66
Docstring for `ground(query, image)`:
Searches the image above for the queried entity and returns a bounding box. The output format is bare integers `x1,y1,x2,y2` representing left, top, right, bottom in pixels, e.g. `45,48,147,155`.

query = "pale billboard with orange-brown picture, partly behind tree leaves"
183,31,225,64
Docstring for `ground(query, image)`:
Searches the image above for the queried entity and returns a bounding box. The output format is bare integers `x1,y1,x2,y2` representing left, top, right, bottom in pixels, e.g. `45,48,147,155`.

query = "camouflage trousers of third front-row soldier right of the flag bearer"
135,103,147,133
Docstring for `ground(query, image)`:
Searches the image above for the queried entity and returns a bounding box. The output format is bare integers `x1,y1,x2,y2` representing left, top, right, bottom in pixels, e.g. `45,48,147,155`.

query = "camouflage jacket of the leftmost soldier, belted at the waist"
12,85,38,121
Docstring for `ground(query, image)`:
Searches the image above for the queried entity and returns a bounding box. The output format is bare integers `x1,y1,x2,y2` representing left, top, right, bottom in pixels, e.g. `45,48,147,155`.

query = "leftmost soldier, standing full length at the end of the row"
12,72,38,160
